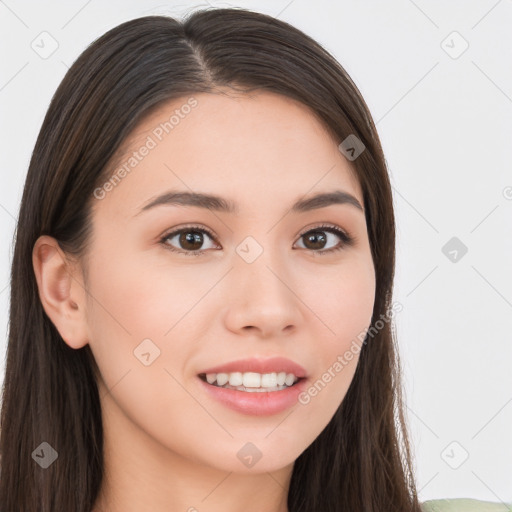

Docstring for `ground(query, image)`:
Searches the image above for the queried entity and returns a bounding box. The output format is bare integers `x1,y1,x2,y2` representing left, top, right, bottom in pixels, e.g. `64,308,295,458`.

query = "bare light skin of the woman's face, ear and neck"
33,91,375,512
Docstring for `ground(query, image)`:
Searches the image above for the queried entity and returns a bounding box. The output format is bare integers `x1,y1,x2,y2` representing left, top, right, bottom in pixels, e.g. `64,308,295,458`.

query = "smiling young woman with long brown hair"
0,9,506,512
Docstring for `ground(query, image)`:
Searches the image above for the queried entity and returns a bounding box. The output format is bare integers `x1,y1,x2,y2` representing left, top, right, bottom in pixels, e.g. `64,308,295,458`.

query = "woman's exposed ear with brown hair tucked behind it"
32,235,89,349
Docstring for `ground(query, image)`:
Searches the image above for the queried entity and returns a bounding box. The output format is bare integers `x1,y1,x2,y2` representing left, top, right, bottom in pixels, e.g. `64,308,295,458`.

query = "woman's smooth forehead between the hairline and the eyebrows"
93,91,363,219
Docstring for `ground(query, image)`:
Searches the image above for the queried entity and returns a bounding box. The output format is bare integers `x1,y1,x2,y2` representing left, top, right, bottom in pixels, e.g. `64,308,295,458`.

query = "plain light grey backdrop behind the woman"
0,0,512,501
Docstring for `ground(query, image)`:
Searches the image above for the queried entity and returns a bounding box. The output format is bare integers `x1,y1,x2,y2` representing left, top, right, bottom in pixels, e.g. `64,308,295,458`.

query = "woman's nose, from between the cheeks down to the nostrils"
224,252,303,339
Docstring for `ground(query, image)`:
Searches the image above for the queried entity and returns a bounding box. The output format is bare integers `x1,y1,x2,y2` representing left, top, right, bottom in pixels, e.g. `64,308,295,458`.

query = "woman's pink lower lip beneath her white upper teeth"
198,377,307,416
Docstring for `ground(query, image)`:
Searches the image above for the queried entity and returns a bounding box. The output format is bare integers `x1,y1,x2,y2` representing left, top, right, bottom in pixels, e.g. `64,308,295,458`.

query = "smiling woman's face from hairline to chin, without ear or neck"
73,92,375,472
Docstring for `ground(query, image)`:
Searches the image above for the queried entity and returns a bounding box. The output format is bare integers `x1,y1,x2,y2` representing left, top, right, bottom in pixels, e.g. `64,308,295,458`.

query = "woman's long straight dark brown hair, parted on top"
0,8,420,512
